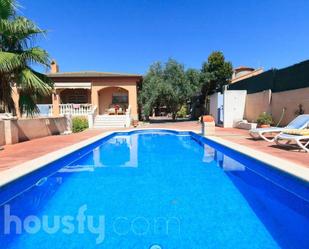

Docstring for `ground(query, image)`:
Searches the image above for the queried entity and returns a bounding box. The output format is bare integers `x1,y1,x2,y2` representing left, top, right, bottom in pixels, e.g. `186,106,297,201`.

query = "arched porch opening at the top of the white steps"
98,87,129,115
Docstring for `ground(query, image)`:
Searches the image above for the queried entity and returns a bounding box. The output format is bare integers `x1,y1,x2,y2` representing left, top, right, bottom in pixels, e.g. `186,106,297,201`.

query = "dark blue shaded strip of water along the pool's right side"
199,138,309,249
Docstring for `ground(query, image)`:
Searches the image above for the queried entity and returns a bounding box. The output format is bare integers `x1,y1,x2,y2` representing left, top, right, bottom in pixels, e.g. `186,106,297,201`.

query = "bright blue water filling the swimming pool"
0,131,309,249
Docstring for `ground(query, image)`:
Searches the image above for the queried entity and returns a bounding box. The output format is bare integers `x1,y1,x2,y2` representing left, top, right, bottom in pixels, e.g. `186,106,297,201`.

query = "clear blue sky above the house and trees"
19,0,309,74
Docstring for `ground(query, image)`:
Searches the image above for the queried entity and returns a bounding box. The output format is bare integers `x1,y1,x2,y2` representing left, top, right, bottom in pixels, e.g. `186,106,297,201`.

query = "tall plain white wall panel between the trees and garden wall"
223,90,247,128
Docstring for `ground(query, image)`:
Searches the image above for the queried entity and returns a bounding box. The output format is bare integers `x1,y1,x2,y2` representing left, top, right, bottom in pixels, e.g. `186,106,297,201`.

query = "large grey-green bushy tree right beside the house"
139,59,199,119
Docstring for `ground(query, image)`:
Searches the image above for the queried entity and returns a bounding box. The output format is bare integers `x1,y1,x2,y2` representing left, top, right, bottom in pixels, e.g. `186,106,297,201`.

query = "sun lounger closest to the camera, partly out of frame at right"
275,129,309,152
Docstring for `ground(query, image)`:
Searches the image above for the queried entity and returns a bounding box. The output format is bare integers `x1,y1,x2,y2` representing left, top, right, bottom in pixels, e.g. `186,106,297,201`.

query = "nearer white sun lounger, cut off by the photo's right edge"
275,133,309,152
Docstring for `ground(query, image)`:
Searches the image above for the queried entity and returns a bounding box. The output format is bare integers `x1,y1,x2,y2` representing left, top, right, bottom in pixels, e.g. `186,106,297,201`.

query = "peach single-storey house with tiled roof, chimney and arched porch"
44,61,142,119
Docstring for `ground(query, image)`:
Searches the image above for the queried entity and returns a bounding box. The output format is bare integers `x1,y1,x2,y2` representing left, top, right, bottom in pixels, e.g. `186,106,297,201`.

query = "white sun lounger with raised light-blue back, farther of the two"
249,114,309,142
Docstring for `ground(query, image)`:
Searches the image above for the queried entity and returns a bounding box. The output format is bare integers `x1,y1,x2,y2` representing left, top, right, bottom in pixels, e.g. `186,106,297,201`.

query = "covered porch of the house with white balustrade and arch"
38,82,137,119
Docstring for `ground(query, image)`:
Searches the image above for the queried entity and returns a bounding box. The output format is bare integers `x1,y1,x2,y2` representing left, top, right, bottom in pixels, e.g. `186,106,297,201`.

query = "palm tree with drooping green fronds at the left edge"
0,0,52,115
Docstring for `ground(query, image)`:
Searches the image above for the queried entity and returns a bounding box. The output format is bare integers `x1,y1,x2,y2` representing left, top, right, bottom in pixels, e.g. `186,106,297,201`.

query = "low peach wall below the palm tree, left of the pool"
4,117,66,144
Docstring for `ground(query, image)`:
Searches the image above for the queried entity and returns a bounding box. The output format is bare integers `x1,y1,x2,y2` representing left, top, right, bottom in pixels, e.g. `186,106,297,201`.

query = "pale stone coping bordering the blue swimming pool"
0,128,309,187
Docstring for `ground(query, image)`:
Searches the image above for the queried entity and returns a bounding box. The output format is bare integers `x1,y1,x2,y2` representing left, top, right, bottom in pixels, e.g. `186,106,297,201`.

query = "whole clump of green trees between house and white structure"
139,52,233,118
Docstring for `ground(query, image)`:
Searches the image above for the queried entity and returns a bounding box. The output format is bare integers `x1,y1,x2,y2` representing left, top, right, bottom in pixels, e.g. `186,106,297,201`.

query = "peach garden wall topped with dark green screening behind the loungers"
228,60,309,125
